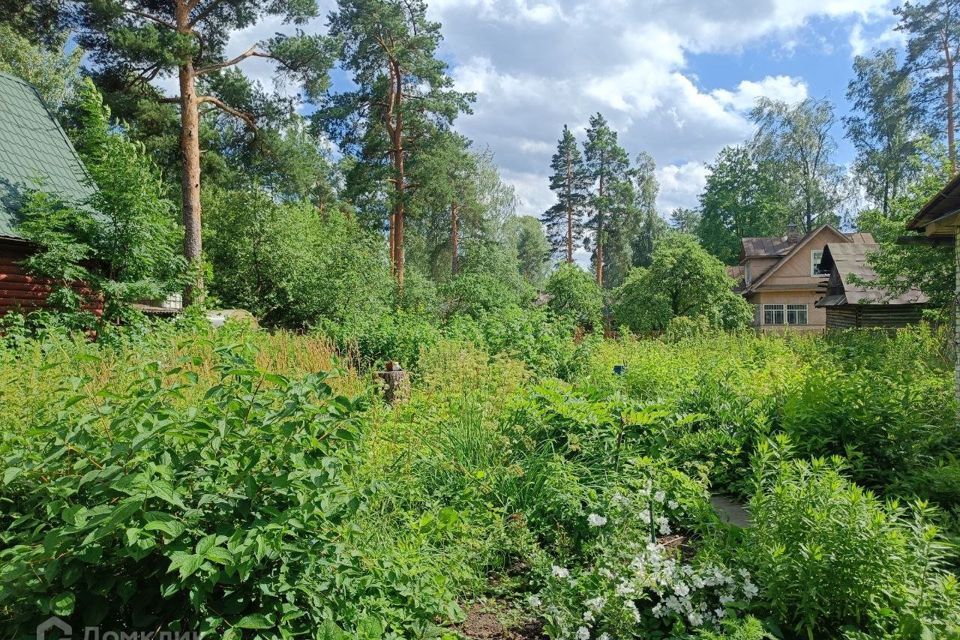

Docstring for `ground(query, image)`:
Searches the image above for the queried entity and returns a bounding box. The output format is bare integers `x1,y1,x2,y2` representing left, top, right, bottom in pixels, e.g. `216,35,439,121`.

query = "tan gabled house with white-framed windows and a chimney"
731,225,873,331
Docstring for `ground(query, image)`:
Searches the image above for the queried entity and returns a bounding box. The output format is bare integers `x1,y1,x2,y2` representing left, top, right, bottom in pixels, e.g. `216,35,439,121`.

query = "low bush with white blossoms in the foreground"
530,479,758,640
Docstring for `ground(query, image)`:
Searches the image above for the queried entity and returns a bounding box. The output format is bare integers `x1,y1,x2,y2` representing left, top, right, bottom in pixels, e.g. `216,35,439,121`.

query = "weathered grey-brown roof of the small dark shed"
816,242,930,307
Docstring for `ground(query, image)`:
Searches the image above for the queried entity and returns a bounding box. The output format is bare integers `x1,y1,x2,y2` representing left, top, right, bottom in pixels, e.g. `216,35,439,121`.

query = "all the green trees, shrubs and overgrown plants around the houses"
0,0,960,640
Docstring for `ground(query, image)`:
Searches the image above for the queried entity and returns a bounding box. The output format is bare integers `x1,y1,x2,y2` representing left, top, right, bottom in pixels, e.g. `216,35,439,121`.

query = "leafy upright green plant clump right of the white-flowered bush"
745,439,958,638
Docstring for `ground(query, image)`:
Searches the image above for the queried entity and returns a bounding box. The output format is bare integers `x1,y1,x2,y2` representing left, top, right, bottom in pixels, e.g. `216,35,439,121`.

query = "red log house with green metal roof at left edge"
0,73,101,315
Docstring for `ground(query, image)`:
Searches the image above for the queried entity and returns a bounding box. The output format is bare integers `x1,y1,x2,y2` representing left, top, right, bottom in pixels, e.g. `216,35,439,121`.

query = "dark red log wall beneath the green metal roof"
0,241,103,316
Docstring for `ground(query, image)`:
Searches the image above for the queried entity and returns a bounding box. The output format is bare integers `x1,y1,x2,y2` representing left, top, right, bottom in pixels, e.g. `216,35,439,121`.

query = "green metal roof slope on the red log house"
0,73,94,238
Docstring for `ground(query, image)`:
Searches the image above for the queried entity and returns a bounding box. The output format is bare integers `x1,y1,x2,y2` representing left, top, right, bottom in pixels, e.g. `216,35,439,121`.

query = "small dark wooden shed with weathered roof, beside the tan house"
816,243,929,329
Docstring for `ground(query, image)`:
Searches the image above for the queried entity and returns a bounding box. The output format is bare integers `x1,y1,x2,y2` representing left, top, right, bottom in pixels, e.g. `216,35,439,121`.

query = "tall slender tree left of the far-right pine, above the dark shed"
843,49,922,215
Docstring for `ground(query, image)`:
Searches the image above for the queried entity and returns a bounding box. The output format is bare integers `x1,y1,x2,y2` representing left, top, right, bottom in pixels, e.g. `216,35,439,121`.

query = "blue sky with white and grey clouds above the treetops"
219,0,916,222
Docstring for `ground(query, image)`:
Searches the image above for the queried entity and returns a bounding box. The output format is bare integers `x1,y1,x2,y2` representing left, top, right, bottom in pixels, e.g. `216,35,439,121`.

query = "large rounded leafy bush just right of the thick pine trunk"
204,182,393,327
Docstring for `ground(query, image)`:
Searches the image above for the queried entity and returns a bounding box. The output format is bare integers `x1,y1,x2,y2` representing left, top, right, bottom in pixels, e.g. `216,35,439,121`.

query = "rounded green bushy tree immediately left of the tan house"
612,234,752,332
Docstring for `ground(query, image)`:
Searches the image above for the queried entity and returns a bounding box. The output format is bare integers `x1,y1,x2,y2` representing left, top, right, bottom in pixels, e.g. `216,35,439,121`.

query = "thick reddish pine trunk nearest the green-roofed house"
175,2,203,305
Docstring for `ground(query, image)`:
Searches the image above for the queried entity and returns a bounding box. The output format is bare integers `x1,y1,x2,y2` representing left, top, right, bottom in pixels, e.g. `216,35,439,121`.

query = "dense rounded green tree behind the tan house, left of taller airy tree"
696,147,789,264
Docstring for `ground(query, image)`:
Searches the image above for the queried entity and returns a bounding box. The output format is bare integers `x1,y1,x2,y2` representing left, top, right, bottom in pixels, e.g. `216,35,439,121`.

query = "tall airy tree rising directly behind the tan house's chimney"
751,98,843,232
